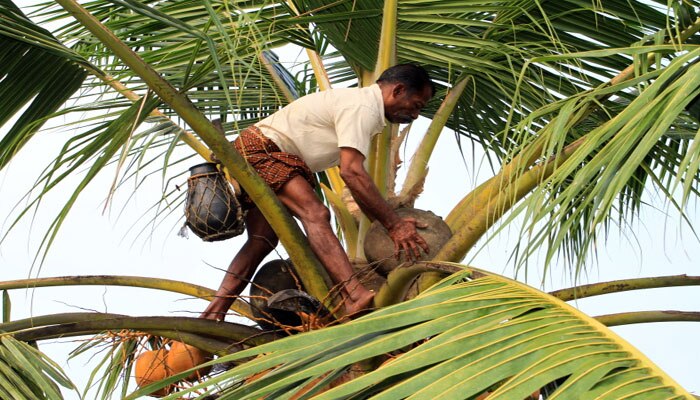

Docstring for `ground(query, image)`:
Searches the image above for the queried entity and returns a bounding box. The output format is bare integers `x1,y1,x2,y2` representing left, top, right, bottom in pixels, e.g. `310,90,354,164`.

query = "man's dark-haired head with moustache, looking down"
377,64,435,124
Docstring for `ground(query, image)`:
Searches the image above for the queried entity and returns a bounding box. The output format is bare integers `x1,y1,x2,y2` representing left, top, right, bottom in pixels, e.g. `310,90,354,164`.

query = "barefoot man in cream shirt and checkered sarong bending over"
201,64,435,320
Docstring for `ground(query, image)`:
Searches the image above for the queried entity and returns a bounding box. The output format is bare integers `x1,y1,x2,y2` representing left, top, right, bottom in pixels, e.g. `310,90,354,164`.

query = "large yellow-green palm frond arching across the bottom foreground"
159,262,690,400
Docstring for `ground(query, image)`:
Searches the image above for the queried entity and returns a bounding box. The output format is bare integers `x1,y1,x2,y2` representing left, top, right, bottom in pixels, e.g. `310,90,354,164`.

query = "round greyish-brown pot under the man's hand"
364,208,452,275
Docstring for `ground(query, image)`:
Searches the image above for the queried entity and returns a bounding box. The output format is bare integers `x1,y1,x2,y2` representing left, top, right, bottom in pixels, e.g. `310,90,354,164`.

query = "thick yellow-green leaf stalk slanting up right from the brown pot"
433,136,586,261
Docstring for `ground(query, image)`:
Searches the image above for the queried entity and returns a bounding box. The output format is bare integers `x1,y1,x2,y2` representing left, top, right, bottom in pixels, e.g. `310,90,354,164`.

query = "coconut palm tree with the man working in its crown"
0,0,700,399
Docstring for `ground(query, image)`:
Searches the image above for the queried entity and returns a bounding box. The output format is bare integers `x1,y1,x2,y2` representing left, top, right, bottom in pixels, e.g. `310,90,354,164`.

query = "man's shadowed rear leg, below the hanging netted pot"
200,207,278,320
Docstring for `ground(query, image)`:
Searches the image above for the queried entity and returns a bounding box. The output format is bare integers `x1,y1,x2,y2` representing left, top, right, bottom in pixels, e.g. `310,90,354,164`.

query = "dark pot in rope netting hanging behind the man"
185,163,245,242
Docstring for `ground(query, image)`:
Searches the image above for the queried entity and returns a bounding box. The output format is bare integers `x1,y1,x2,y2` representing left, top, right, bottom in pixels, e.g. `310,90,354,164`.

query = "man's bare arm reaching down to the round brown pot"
340,147,430,258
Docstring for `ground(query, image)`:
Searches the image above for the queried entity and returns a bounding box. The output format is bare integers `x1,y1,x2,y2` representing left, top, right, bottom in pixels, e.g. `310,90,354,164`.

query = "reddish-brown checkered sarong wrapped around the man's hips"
233,125,316,210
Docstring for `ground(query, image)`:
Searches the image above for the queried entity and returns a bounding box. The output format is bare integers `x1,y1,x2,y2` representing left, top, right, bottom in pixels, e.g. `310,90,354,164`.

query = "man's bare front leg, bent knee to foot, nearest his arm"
277,176,374,315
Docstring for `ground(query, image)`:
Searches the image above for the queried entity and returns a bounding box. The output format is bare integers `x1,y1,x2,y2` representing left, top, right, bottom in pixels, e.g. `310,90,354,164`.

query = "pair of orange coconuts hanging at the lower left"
134,341,211,397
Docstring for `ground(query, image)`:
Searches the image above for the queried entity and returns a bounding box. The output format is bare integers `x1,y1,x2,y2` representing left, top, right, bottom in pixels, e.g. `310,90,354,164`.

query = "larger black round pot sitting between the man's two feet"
250,260,302,330
